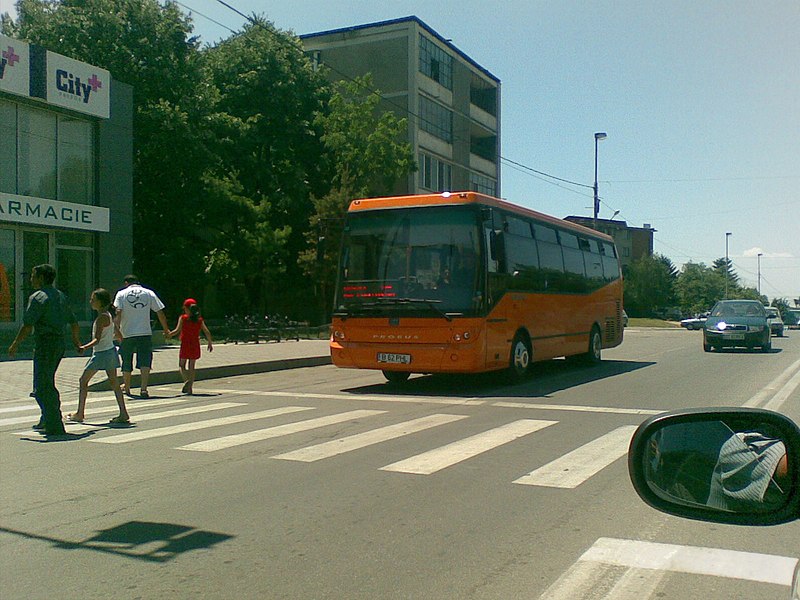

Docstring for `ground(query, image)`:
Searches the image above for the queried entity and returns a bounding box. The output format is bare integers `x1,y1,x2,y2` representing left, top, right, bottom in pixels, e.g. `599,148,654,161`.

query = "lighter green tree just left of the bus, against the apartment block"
299,75,416,324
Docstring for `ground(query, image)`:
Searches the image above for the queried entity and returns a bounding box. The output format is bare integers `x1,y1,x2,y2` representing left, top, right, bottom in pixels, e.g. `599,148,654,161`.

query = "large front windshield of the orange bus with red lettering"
336,206,484,319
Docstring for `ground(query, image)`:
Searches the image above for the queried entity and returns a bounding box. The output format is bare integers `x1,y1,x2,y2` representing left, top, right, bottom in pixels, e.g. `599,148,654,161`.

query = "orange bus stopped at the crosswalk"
330,192,623,383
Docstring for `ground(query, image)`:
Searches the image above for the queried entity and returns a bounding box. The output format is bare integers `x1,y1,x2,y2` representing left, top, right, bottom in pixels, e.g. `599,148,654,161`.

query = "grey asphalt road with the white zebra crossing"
0,329,800,600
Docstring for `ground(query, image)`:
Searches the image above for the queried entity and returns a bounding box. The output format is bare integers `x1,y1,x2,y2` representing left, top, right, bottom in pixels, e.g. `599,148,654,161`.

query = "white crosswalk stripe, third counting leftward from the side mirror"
272,415,467,462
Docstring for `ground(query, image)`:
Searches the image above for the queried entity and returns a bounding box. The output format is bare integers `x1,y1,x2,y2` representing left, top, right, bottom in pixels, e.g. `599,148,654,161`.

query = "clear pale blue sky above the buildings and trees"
0,0,800,298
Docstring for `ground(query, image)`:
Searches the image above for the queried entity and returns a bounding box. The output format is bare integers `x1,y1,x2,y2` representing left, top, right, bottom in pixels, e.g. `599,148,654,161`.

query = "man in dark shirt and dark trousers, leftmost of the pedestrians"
8,265,81,435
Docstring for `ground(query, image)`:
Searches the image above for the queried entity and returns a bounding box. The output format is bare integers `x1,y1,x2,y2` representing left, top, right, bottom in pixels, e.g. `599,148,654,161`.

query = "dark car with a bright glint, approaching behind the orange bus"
703,300,772,352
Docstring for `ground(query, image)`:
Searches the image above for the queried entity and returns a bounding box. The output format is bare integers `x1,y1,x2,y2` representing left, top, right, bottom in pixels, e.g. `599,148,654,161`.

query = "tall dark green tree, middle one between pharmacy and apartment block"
204,17,331,312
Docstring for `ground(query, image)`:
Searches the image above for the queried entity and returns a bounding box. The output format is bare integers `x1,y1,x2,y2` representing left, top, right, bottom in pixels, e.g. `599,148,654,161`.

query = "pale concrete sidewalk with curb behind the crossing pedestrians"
0,340,331,402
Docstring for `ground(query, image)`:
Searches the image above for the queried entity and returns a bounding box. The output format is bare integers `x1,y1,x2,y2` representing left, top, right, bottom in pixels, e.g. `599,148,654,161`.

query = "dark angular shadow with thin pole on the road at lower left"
0,521,233,563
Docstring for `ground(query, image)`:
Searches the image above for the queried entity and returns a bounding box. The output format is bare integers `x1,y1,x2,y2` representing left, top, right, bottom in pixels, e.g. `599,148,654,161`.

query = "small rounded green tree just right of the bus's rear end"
625,254,677,316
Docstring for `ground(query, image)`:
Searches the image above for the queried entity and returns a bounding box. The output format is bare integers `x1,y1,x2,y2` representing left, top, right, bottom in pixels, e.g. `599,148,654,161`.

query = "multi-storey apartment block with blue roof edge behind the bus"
300,16,500,196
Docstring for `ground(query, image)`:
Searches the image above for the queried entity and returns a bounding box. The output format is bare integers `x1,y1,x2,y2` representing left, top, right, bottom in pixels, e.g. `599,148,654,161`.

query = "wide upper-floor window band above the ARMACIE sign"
0,101,95,204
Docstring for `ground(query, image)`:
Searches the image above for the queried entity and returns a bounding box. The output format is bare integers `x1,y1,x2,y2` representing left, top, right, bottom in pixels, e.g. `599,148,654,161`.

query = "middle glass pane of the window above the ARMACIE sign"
18,105,58,200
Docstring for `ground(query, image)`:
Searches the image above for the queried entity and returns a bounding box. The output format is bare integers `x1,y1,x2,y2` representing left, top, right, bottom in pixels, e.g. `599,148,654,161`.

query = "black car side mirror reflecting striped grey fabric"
628,408,800,525
